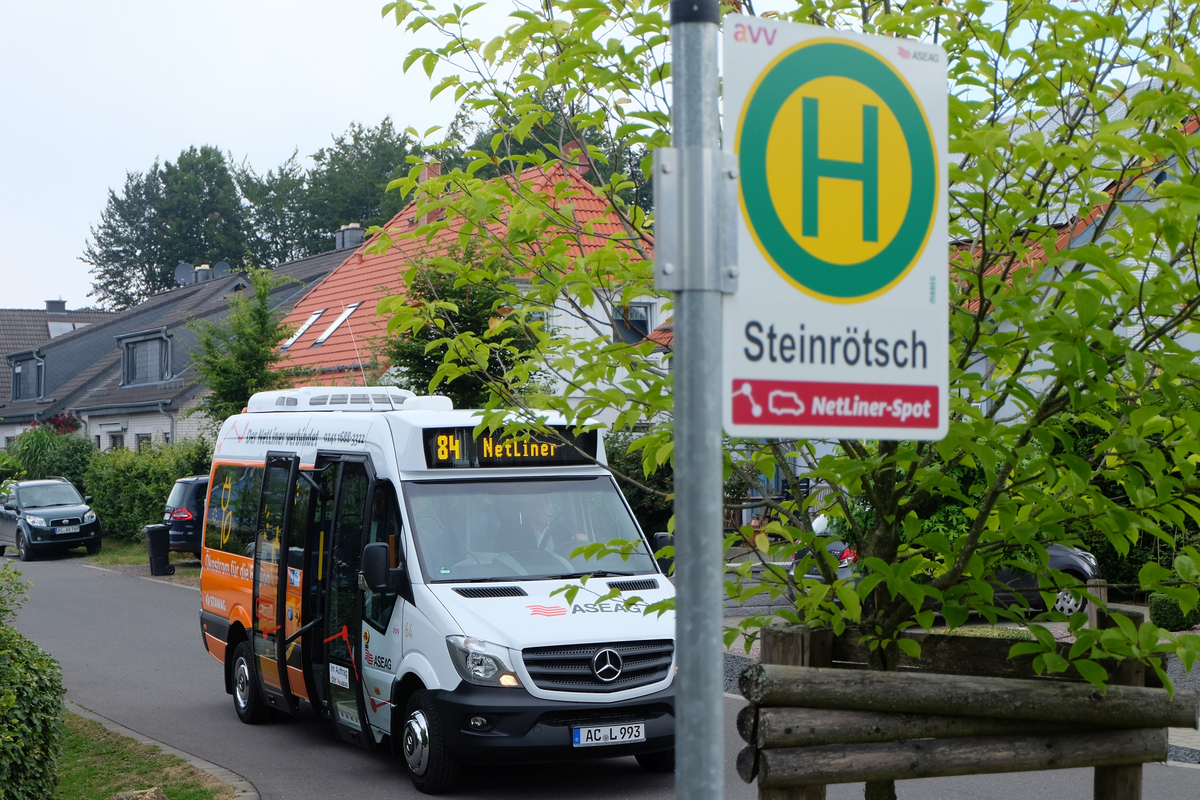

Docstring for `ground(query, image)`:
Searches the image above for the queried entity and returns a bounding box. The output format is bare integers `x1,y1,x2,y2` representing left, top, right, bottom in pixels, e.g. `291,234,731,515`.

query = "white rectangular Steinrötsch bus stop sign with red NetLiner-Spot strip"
721,16,949,439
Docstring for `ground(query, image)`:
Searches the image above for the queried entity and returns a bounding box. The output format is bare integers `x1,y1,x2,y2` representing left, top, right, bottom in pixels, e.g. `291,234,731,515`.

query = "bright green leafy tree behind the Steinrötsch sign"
384,0,1200,767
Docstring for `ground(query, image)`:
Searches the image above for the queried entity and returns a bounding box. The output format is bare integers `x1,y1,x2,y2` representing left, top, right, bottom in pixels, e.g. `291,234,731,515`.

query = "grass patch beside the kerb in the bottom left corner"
54,711,234,800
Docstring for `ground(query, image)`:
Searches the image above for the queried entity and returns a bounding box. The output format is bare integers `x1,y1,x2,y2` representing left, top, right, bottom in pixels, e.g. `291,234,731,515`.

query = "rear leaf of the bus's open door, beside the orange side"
253,453,300,714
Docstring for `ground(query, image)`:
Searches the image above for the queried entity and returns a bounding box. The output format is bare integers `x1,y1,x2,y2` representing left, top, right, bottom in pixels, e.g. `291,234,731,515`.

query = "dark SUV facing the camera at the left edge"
0,477,102,561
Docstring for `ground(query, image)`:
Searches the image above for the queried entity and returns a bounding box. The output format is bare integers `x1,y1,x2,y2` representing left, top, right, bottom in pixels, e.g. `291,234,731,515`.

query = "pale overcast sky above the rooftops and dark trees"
0,0,496,308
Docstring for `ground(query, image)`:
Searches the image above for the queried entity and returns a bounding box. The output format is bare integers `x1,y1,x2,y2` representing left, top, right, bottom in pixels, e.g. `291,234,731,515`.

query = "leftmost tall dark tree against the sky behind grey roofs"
80,146,247,311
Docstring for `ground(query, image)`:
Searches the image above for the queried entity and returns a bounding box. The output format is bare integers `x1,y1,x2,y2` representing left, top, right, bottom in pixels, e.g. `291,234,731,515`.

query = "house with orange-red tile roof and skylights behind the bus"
274,162,662,407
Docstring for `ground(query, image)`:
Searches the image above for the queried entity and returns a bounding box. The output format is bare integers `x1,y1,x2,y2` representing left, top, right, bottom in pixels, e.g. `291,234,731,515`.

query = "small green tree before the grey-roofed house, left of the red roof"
190,269,292,432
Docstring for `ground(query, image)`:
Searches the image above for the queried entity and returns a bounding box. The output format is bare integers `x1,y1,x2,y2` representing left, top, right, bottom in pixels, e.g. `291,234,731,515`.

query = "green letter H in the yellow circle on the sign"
800,97,880,241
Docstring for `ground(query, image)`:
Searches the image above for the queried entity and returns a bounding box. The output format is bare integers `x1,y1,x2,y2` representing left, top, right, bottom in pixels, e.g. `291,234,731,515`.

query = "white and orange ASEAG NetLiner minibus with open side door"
200,386,676,794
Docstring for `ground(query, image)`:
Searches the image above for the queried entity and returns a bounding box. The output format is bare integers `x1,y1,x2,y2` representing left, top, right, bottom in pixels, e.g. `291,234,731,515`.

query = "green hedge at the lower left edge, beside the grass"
0,625,64,800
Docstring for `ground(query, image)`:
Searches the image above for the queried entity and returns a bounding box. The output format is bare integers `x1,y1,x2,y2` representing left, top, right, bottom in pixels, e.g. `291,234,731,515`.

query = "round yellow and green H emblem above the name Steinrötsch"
737,38,940,302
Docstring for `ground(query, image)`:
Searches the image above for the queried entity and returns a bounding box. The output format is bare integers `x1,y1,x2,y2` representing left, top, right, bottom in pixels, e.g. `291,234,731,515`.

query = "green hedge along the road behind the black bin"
84,439,212,541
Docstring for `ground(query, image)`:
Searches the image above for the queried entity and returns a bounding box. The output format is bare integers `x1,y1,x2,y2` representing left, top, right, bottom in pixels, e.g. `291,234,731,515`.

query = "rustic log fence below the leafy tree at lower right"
737,585,1200,800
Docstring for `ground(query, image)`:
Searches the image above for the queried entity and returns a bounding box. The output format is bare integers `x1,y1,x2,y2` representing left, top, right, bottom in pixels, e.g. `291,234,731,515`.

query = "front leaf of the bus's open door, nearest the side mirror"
324,461,374,748
